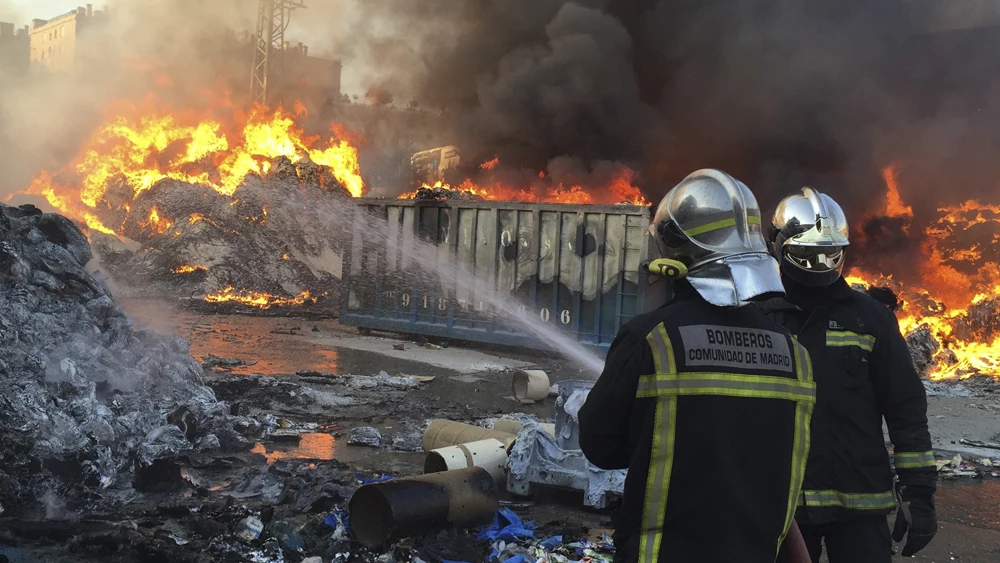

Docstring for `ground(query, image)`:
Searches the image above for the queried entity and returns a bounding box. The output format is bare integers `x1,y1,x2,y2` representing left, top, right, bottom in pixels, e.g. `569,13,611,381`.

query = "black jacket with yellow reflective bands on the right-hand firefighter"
761,278,937,524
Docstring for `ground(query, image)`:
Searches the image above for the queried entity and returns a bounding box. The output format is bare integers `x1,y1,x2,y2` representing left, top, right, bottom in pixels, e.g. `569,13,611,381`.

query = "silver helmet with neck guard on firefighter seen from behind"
650,169,784,307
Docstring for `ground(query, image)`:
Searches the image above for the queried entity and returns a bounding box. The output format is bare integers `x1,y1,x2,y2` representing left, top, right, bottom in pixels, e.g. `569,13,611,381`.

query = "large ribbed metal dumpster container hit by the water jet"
341,199,668,355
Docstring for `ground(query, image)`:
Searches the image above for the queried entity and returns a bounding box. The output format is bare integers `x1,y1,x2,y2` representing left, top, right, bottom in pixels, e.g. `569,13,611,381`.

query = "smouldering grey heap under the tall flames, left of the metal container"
93,157,351,313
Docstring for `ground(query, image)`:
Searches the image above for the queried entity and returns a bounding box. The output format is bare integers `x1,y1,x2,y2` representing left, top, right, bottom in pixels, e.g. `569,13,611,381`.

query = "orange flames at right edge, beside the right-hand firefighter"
846,167,1000,380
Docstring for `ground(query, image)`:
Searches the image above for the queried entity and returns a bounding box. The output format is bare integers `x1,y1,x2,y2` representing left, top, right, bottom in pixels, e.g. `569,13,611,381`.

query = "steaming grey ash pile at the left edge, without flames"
0,205,260,518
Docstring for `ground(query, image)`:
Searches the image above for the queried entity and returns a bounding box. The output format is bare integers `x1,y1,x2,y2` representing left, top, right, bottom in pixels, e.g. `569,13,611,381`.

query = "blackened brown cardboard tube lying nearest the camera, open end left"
348,467,500,547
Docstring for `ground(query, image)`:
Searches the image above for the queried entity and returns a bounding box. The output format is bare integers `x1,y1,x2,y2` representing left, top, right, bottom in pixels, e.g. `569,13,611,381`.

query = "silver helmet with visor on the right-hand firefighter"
768,188,850,286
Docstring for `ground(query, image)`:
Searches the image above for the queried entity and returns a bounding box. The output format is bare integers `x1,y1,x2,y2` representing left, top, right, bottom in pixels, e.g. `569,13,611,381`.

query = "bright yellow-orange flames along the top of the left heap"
19,104,364,234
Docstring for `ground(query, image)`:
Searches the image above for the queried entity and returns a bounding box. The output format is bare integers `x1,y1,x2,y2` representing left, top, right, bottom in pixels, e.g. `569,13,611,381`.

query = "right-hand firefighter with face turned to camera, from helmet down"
761,188,937,563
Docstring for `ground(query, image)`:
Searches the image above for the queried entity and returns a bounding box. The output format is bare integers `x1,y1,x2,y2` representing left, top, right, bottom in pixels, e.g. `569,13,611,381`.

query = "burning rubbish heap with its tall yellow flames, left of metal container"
27,102,363,309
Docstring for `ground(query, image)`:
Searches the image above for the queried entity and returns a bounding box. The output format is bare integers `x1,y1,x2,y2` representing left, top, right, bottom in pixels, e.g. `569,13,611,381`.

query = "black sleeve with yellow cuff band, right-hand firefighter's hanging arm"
871,309,937,487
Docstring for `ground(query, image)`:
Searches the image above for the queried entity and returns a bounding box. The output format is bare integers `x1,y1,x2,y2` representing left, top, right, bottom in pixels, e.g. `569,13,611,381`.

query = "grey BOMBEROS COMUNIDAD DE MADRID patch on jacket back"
677,325,795,373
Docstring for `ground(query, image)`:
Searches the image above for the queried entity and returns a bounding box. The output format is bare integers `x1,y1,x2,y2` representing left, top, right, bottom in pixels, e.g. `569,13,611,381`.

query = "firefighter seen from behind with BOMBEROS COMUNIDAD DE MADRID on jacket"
579,170,815,563
